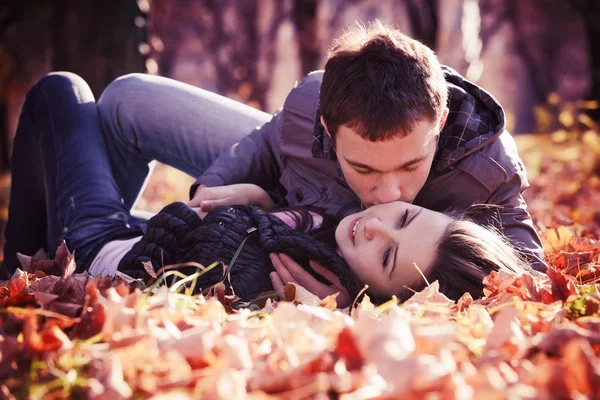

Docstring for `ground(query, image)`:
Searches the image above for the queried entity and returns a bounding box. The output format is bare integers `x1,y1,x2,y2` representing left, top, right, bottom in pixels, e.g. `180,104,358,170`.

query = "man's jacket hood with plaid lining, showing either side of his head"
312,66,505,173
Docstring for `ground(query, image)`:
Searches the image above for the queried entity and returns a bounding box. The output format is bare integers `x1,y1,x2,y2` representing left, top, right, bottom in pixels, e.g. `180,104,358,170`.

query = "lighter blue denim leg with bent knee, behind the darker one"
98,74,271,207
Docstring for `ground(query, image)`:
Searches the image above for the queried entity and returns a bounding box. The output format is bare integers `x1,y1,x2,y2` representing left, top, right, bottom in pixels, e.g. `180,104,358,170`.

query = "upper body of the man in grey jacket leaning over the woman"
180,22,545,289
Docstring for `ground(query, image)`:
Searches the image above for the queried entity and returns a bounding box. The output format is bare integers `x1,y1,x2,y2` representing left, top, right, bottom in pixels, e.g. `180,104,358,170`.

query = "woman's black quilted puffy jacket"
118,202,359,301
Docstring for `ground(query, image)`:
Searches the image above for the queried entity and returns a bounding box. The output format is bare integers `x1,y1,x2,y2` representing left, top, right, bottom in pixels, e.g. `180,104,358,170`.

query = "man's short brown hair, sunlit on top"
319,20,448,142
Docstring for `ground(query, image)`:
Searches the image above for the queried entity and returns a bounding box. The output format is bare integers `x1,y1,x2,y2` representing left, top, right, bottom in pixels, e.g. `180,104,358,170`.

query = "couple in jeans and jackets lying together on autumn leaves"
4,22,545,306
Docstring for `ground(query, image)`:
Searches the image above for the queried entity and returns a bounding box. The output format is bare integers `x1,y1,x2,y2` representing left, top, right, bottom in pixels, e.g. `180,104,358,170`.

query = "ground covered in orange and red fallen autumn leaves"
0,132,600,399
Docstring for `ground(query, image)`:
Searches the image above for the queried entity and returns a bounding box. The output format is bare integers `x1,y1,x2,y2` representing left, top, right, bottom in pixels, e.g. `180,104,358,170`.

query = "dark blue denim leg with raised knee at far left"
7,73,145,270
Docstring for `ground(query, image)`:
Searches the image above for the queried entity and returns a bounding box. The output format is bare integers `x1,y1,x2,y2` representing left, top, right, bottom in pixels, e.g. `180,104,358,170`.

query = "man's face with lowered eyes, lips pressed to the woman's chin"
324,111,447,207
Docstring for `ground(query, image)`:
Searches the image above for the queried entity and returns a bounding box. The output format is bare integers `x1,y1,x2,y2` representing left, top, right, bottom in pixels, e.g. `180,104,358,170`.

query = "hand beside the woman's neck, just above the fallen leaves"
269,253,352,308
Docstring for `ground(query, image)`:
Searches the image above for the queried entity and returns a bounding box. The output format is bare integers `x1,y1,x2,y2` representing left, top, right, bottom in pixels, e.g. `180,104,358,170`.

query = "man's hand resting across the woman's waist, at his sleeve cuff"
187,183,275,212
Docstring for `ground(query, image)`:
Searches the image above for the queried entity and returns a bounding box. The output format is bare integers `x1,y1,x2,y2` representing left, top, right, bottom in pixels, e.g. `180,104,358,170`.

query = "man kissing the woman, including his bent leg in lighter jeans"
5,22,544,293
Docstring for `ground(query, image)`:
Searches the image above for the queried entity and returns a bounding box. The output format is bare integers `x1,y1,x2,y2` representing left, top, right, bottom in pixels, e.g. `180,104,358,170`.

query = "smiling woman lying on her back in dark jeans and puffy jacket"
4,74,523,302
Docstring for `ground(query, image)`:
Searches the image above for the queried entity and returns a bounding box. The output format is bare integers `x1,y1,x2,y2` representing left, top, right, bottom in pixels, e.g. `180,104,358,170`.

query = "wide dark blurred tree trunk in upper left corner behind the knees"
0,0,146,171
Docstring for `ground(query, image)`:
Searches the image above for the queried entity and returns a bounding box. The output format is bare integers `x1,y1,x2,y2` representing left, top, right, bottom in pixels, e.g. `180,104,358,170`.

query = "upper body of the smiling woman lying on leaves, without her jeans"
113,194,528,305
